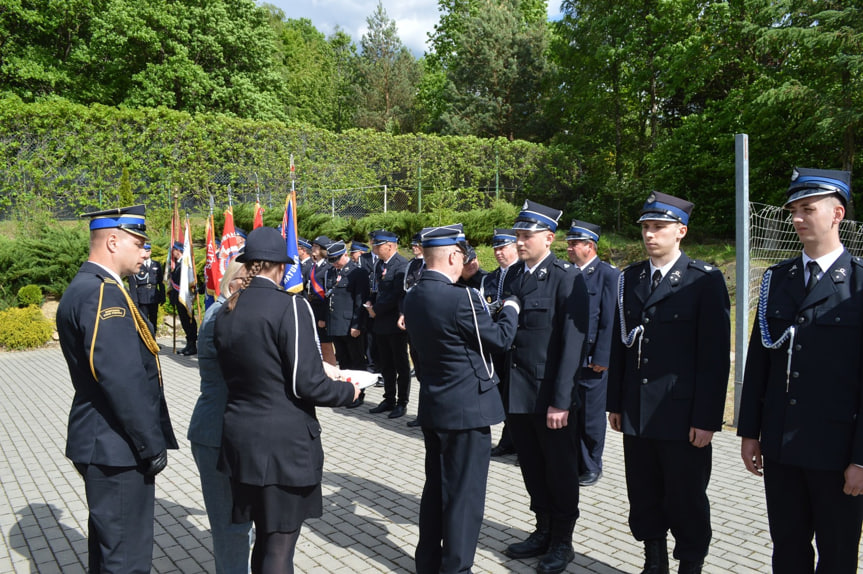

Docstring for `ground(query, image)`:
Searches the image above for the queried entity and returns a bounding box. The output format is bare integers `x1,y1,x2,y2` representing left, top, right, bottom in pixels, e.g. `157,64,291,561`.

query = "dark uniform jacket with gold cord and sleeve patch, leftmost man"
57,262,177,467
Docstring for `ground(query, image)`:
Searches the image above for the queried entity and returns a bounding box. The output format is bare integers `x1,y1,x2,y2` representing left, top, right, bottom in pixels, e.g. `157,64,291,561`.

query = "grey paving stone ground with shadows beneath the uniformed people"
0,341,863,574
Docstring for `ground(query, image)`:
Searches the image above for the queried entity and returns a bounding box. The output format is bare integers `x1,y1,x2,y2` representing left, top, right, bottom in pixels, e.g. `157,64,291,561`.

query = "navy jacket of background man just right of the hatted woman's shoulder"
327,261,369,337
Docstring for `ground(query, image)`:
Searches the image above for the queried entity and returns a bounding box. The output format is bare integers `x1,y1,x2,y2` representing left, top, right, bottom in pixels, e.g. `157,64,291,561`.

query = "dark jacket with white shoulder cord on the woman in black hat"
214,277,354,486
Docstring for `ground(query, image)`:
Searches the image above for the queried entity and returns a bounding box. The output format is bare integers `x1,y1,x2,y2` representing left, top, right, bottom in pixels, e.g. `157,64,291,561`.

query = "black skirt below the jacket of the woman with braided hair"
231,480,324,533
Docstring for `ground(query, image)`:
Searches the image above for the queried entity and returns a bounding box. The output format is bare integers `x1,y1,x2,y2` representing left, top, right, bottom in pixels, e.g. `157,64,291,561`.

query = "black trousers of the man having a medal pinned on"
506,409,579,522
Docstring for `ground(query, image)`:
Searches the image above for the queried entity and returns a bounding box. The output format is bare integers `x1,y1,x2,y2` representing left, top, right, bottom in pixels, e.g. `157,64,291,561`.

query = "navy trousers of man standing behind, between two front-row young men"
578,367,608,473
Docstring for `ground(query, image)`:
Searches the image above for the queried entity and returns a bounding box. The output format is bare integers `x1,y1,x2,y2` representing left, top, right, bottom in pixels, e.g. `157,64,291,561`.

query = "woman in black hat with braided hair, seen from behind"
215,227,359,574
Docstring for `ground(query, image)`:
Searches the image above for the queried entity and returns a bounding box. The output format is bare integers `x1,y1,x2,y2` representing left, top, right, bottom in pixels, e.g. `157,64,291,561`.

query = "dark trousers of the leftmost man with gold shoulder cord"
75,463,156,574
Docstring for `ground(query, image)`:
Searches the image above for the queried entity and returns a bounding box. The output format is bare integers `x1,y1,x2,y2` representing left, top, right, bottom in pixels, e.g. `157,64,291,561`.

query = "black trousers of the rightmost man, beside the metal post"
764,457,863,574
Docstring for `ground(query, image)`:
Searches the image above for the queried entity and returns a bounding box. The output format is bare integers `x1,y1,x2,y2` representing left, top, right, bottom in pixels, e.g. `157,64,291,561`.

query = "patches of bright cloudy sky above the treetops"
258,0,560,57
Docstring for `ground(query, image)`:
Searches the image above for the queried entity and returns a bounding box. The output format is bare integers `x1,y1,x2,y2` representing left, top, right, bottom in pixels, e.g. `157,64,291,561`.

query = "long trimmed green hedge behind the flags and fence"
0,97,577,216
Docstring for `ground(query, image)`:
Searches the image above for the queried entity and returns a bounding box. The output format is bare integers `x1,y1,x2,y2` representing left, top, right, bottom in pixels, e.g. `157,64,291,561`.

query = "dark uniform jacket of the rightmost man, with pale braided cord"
737,251,863,470
